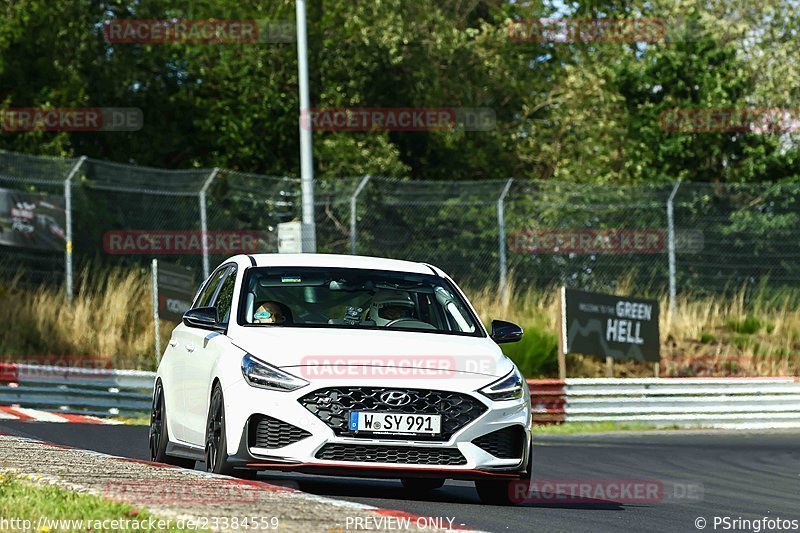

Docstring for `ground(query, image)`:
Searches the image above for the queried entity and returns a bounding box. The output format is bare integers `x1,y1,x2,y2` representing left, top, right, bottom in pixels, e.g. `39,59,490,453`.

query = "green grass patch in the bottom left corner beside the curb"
0,473,195,531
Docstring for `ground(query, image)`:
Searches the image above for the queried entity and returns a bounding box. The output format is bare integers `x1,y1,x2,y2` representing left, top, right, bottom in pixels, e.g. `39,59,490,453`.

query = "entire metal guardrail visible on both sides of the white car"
0,363,800,428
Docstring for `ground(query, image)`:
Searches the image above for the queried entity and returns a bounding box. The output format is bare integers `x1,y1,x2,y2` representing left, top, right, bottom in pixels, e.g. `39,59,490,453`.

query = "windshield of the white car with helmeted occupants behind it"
238,267,483,336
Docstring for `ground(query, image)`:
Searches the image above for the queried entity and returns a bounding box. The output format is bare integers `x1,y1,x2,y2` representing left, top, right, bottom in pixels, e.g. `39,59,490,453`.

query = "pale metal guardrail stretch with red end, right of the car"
528,377,800,428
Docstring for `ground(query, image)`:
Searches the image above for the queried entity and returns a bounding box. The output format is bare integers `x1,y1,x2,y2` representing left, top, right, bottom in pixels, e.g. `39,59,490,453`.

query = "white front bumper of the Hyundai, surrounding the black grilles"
225,380,531,479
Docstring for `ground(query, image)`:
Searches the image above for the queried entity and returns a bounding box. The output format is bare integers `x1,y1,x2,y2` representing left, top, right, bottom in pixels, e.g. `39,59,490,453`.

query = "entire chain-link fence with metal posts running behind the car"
0,152,800,304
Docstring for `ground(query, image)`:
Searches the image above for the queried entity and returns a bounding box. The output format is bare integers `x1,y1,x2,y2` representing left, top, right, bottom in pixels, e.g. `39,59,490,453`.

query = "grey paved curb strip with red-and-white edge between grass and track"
0,435,482,533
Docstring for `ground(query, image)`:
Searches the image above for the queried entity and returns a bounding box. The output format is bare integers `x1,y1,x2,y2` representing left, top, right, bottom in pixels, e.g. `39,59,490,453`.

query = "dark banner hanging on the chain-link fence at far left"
0,189,66,251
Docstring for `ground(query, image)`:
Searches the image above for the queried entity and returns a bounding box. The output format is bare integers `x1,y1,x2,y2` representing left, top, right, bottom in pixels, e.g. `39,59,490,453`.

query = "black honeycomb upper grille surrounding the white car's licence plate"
299,387,487,441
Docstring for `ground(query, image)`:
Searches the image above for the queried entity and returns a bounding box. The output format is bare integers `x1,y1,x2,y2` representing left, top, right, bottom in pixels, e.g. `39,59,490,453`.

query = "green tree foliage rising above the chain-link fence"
0,0,800,183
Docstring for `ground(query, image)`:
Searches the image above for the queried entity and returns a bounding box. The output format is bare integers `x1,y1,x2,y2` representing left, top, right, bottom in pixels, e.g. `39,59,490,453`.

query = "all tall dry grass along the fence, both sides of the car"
0,269,800,377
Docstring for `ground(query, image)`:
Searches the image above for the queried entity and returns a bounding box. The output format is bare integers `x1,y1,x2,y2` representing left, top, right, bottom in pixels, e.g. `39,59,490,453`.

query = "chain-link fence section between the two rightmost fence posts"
506,181,681,293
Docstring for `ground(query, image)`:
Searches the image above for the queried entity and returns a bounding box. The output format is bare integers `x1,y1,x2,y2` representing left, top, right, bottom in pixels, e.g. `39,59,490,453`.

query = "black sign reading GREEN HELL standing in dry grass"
561,288,661,361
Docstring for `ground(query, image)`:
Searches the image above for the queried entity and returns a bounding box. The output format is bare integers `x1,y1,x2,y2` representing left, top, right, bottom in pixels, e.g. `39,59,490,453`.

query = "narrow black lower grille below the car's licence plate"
316,444,467,466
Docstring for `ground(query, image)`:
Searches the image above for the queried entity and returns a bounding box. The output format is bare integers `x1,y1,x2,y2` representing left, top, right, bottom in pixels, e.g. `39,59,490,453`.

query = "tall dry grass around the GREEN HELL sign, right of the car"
470,279,800,377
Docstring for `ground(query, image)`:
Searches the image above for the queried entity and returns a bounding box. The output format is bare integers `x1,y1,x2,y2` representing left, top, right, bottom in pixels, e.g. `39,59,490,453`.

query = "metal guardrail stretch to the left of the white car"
0,363,155,416
